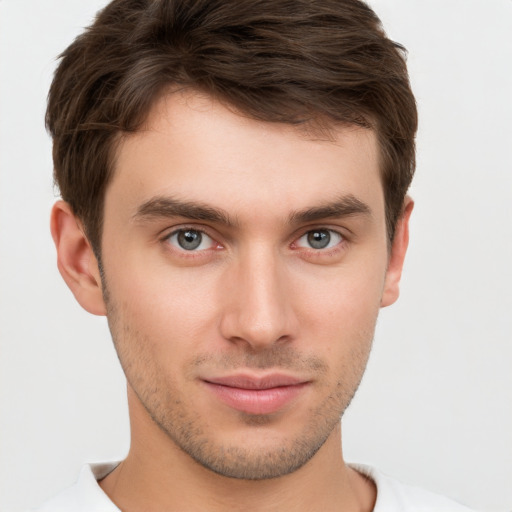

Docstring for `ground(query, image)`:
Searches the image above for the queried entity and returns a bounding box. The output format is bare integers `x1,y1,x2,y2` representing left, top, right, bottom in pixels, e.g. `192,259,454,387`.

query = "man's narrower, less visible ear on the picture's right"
380,196,414,307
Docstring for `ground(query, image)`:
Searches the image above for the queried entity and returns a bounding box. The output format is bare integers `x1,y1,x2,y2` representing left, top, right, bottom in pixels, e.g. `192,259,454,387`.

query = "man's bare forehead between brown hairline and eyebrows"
105,91,383,223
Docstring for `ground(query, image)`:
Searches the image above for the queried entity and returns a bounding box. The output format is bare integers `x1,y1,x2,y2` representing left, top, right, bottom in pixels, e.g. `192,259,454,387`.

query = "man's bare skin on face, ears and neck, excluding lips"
52,92,412,512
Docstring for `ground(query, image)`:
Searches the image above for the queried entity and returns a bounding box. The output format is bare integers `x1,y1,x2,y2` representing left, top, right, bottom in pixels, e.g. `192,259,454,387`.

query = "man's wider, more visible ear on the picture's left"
50,201,106,315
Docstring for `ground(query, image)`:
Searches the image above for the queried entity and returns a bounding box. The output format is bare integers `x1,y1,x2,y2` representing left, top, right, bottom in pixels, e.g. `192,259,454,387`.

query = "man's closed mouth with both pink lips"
203,373,310,414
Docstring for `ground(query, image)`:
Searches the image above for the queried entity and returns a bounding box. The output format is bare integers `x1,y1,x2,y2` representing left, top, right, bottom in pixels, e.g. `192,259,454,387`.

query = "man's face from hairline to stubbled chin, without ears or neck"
102,93,394,479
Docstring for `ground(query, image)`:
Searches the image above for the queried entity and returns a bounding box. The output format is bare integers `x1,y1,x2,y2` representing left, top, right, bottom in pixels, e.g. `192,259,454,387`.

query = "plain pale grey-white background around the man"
0,0,512,512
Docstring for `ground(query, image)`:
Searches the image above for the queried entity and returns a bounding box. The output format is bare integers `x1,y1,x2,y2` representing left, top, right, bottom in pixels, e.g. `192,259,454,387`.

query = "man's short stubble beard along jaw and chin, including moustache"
104,280,373,480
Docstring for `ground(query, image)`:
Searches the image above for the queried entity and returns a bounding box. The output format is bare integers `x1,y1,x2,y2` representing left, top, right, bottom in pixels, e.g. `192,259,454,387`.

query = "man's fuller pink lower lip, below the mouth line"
205,382,307,414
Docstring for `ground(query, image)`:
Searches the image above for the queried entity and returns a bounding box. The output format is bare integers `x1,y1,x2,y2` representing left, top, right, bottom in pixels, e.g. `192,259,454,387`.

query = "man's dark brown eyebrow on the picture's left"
133,196,236,226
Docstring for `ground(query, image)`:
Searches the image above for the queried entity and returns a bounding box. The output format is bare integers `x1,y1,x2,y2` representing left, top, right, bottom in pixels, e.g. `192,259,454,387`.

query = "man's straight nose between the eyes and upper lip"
220,249,297,351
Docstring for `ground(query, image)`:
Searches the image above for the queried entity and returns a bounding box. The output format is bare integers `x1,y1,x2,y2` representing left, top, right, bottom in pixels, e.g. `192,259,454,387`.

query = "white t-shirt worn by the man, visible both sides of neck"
34,463,478,512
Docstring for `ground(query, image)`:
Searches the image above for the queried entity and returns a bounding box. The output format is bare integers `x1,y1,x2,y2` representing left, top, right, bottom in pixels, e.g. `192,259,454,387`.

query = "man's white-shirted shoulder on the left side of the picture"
31,462,120,512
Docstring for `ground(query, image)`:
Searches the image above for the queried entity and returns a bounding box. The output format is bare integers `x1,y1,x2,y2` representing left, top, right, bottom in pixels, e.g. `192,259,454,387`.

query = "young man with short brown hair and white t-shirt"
36,0,476,512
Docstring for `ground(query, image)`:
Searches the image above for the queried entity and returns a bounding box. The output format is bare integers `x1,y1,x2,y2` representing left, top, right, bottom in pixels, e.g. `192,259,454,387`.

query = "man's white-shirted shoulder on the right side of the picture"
350,464,475,512
